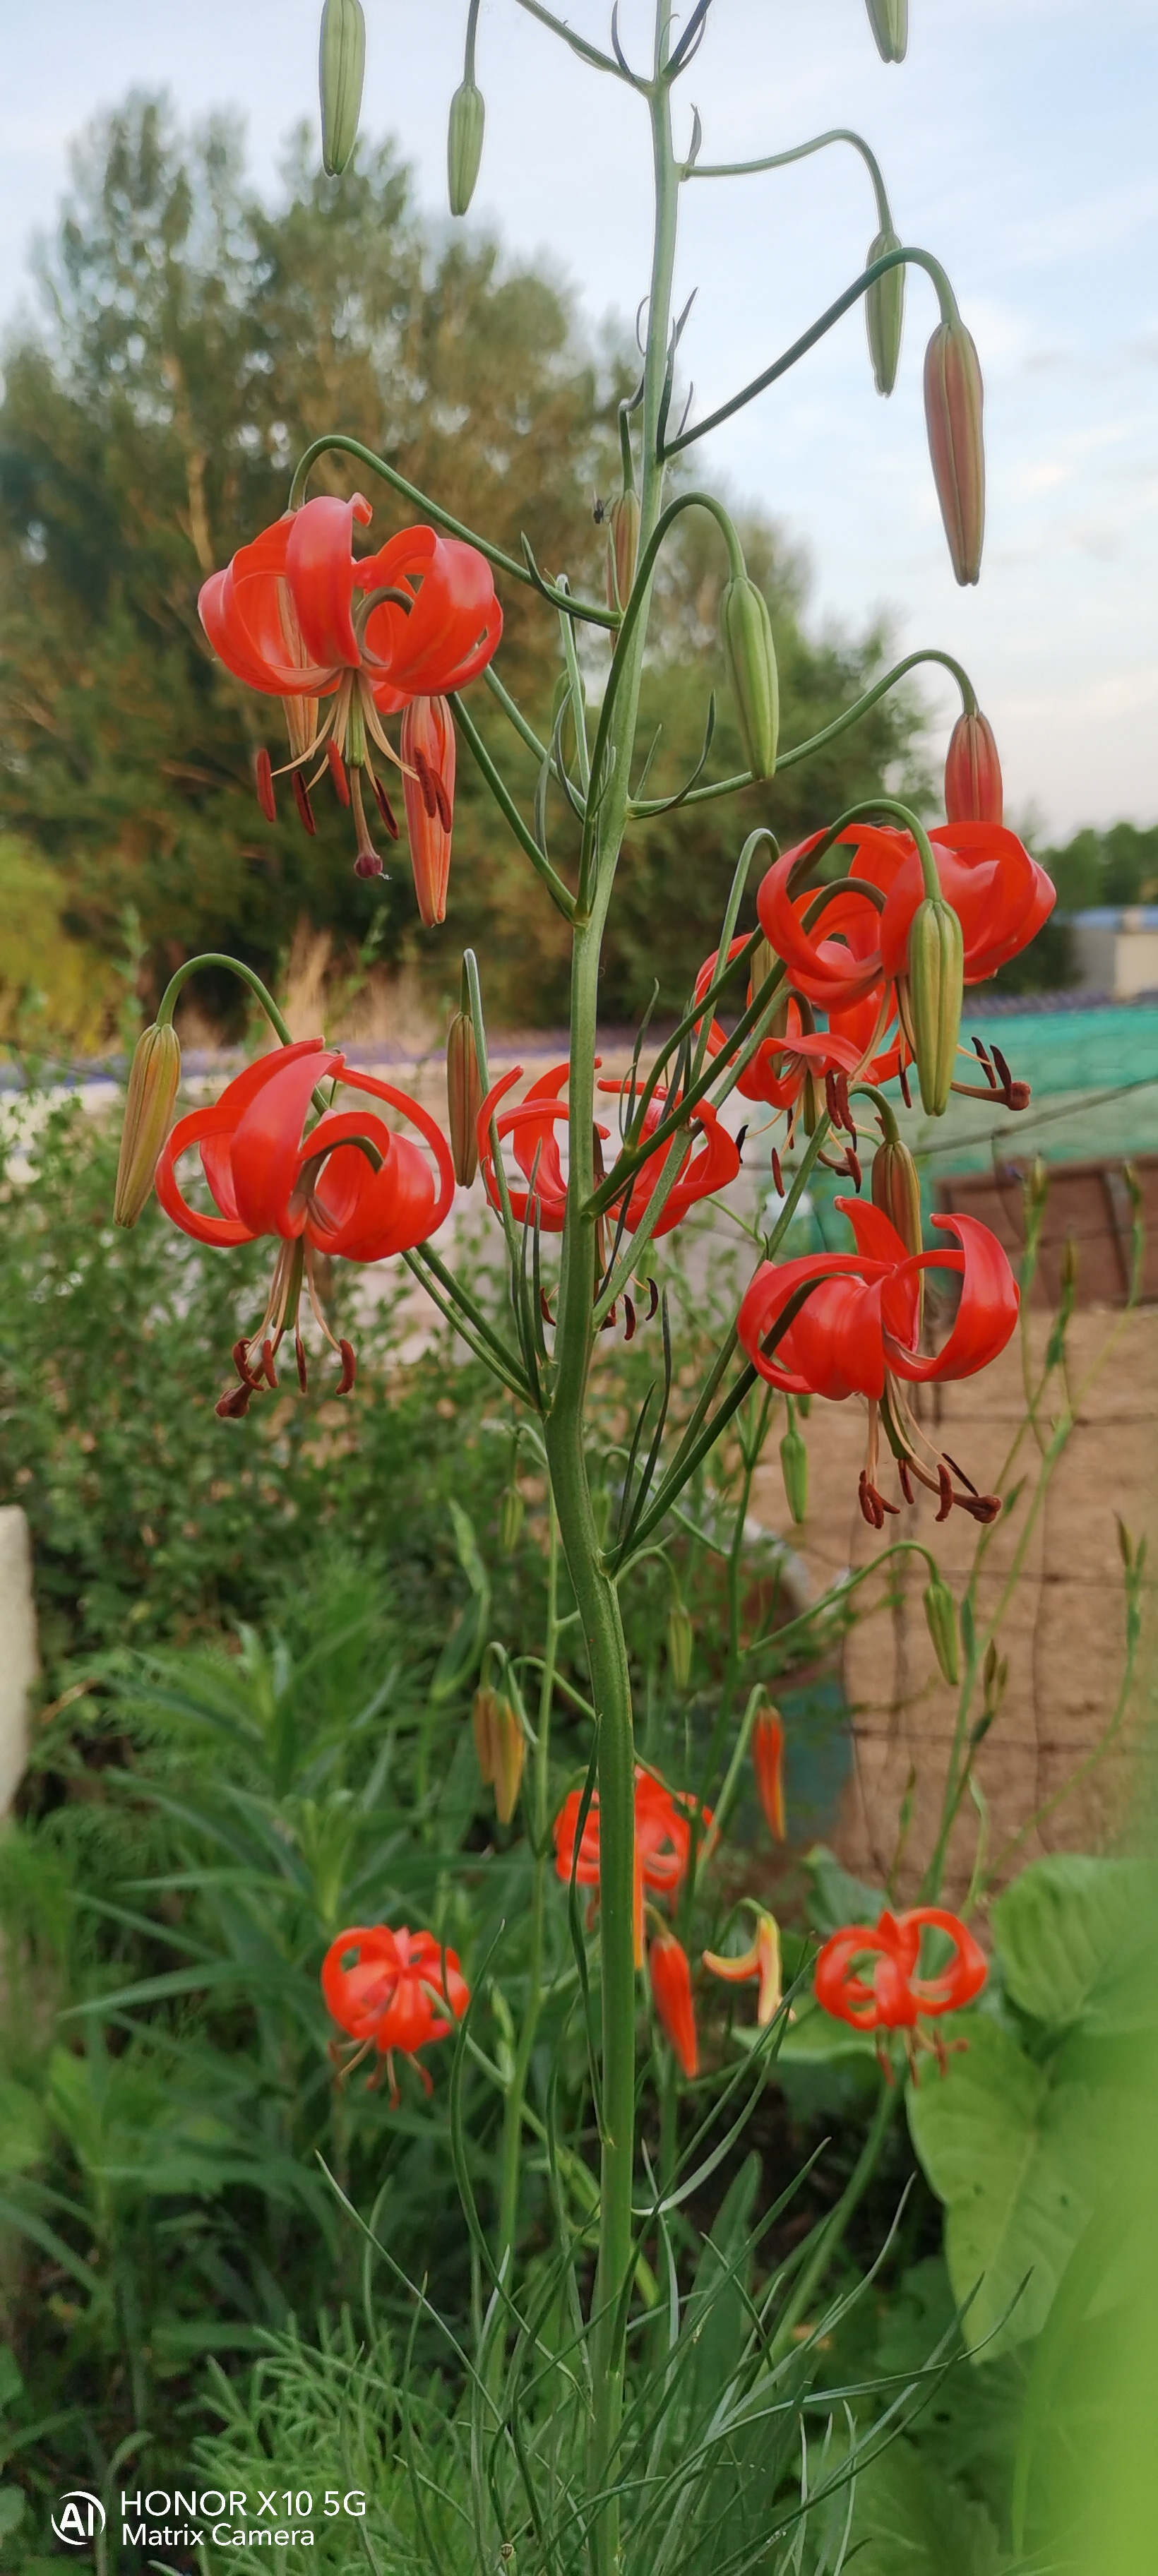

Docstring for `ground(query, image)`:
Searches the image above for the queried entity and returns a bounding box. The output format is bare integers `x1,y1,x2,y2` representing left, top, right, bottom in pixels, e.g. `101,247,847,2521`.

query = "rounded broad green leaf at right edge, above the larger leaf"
993,1852,1153,2038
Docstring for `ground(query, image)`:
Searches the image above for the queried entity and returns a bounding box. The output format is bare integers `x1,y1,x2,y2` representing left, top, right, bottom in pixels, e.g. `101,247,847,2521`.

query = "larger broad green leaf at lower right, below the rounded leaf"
908,2015,1111,2354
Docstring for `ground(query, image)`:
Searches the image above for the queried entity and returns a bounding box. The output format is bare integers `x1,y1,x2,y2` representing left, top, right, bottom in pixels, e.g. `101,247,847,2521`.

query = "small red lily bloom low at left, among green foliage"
322,1924,471,2104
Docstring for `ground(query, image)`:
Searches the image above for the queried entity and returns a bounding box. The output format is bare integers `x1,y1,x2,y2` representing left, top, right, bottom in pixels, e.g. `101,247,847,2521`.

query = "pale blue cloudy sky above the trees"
0,0,1158,837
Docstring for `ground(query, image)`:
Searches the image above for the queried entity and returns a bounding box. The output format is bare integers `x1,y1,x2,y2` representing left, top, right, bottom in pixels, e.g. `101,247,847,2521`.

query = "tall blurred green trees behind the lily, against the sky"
0,95,916,1020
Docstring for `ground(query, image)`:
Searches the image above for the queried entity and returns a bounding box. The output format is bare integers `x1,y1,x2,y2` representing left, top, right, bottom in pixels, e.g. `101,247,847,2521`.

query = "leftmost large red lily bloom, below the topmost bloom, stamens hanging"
157,1038,455,1417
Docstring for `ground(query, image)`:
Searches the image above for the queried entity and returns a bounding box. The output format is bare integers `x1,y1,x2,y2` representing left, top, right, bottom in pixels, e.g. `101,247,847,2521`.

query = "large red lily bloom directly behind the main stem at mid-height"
479,1064,741,1236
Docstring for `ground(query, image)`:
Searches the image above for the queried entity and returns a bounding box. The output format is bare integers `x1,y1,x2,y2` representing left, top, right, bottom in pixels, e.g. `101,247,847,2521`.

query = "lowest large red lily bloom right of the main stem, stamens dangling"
736,1198,1019,1527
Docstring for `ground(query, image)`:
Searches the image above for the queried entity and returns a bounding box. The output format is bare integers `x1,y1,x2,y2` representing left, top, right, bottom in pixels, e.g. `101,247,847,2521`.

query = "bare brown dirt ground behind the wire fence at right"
754,1306,1158,1896
